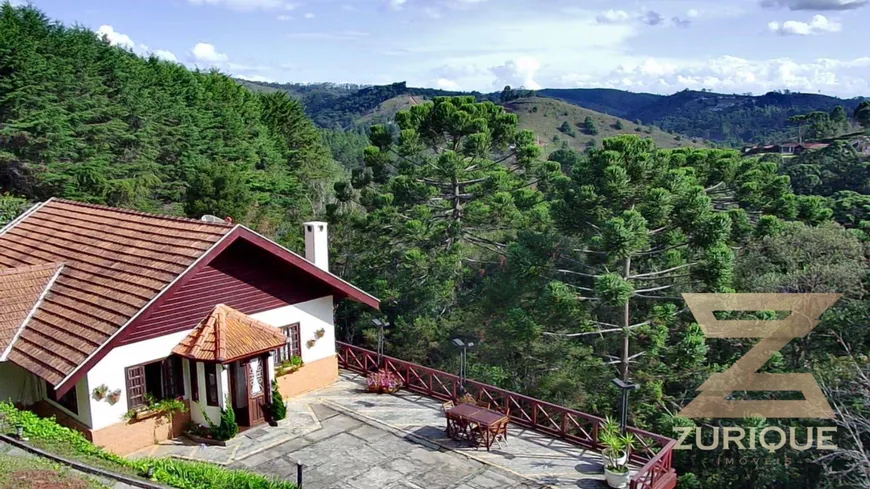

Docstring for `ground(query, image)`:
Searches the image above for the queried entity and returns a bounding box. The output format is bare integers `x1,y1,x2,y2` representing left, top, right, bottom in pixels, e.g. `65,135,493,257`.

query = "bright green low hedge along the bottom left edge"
0,402,296,489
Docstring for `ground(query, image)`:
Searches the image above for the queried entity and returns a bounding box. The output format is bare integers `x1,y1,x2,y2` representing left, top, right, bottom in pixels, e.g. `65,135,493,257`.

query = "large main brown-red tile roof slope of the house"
0,199,233,385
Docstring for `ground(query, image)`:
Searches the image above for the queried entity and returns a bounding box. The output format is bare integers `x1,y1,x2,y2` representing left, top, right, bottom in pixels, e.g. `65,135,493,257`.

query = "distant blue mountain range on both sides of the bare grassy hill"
241,81,863,147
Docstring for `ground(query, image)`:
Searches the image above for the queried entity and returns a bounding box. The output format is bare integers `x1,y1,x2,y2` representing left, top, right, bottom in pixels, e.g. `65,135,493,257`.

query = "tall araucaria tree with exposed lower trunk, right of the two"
547,136,788,420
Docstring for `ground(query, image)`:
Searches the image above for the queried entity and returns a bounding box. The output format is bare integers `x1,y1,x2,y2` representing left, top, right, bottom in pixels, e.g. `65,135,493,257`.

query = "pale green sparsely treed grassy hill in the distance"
505,97,704,153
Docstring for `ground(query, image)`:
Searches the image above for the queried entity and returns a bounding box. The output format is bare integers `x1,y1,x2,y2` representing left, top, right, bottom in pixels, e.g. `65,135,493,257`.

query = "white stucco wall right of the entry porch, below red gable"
251,296,335,363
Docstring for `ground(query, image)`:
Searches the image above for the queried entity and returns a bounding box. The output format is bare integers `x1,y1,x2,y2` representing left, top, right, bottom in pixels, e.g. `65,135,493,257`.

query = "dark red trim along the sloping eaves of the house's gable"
55,226,380,396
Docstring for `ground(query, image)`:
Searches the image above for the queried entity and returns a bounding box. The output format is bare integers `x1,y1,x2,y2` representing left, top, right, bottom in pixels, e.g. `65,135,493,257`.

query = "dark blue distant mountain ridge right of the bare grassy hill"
538,89,862,146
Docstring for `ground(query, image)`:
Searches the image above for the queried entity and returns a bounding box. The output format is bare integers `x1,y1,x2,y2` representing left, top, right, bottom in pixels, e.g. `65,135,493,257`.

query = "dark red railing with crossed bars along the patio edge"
336,342,677,489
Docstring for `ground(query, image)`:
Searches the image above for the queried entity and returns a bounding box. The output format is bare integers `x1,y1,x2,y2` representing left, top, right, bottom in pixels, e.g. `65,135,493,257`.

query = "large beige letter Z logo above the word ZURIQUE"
680,294,842,419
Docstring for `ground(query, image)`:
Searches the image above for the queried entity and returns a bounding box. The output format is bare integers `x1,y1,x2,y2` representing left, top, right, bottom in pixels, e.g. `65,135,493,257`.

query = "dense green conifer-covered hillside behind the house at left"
0,4,342,238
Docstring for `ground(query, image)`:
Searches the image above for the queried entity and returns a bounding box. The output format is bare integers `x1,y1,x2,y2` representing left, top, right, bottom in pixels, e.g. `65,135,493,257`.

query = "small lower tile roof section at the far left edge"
0,263,63,360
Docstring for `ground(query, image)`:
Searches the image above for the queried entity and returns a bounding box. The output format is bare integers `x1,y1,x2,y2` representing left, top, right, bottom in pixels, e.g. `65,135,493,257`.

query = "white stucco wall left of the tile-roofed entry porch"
86,330,190,430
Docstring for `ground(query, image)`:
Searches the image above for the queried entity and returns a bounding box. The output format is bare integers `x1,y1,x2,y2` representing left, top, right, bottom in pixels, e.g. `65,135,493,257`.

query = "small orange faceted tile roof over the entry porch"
172,304,287,363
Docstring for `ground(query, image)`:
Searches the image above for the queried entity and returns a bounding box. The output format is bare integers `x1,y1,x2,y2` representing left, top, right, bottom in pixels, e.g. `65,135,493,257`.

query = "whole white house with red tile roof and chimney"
0,199,379,454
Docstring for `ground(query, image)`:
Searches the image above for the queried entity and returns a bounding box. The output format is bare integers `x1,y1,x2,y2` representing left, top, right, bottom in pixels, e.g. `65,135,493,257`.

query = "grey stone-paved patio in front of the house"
135,371,632,489
